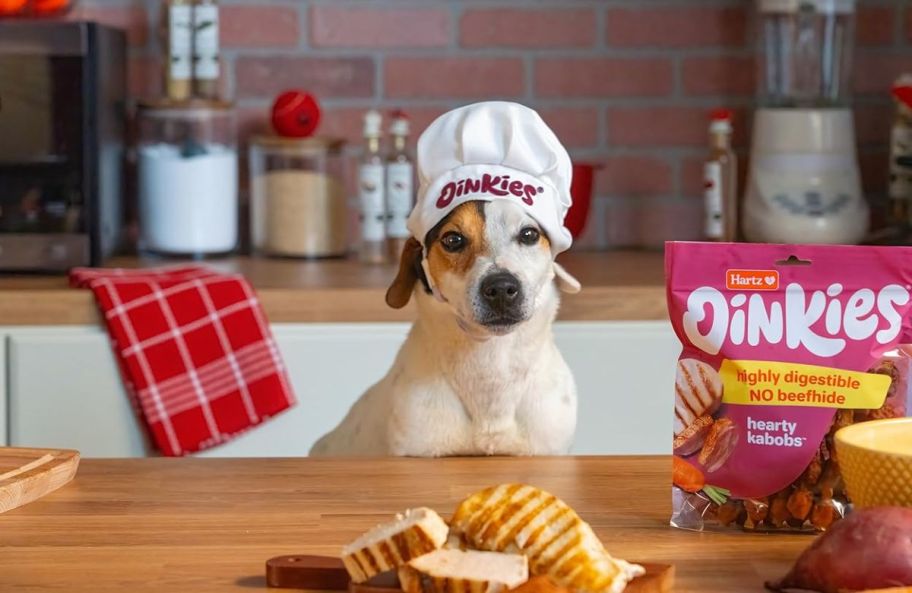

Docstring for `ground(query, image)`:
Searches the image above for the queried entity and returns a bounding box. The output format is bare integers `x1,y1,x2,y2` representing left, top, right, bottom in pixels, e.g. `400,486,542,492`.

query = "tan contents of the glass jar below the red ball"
251,169,348,257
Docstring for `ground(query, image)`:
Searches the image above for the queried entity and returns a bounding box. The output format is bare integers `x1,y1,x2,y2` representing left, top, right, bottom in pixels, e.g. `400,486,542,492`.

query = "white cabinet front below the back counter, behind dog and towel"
0,322,679,457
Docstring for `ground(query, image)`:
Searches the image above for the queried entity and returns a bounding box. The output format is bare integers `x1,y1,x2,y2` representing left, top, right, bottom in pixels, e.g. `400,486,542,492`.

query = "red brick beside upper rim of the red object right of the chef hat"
596,155,672,197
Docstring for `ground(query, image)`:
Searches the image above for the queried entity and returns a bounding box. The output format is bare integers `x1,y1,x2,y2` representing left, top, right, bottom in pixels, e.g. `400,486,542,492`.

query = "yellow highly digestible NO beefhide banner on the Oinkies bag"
719,360,891,409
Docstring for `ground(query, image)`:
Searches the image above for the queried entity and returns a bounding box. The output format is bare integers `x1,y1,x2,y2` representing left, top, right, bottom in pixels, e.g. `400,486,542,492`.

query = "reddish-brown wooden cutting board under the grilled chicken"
266,554,675,593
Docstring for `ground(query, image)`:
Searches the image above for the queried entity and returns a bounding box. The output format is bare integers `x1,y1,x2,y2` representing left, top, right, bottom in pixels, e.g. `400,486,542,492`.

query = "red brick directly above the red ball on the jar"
235,56,374,99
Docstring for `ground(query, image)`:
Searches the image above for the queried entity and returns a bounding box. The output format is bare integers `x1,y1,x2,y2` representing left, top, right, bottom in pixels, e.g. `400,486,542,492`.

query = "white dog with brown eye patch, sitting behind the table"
311,199,580,457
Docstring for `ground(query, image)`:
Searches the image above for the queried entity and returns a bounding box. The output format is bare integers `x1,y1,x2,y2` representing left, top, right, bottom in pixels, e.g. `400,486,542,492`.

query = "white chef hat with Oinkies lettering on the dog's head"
408,101,572,256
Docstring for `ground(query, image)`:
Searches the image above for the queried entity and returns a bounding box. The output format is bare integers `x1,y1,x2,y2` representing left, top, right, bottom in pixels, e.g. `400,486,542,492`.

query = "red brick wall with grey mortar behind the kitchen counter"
74,0,912,248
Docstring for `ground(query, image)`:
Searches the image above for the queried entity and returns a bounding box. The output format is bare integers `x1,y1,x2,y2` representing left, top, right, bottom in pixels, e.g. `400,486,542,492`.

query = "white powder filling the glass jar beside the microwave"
139,144,238,254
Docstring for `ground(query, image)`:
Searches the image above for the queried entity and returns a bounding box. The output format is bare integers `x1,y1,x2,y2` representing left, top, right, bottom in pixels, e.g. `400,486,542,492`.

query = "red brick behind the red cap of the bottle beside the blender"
607,107,748,147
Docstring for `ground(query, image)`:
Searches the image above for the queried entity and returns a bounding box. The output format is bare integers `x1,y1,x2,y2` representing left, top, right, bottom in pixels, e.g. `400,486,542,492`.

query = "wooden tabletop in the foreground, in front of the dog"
0,457,811,593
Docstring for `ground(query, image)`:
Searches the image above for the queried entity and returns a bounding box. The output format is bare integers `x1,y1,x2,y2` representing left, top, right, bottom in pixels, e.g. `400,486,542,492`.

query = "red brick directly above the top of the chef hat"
384,57,525,99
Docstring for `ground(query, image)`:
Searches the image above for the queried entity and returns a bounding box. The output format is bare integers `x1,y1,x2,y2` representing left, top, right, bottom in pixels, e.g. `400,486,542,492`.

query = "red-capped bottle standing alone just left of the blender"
703,109,738,242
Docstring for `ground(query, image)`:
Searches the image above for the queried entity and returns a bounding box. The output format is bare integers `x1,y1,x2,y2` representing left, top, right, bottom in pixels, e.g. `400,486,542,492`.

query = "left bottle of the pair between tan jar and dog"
358,109,386,264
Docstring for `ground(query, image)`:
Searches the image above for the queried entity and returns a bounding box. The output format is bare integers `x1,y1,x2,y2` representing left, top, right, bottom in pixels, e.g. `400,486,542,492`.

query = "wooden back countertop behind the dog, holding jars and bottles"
0,252,667,326
